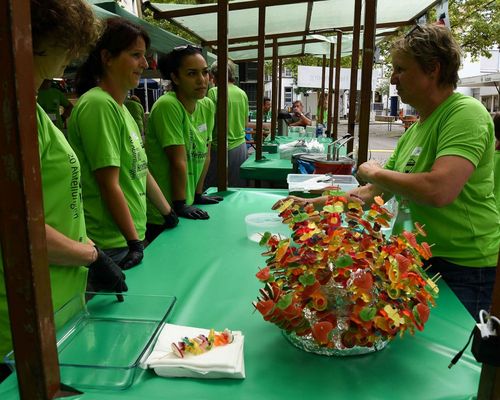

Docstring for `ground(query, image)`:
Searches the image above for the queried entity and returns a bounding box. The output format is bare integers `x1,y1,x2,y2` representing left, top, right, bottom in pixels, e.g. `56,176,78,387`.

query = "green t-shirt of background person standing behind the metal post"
207,83,248,150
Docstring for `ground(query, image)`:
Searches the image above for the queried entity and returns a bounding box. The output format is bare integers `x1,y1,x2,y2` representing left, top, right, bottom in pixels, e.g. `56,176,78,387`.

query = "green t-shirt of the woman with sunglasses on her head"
146,92,215,224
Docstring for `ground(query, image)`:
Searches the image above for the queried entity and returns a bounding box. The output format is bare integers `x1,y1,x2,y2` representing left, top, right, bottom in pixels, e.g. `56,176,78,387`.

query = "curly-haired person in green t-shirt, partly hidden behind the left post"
0,0,127,381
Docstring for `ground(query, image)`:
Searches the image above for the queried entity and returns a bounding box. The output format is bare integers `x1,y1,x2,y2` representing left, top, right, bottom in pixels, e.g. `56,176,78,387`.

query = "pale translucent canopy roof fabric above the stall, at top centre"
151,0,439,60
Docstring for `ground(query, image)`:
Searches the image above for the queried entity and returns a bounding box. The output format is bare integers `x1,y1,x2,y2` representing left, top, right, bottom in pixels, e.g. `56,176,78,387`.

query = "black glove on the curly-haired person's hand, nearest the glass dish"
88,247,128,293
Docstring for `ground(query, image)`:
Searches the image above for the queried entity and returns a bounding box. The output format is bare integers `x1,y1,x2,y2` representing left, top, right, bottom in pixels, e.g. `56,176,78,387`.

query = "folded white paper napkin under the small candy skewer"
142,324,245,379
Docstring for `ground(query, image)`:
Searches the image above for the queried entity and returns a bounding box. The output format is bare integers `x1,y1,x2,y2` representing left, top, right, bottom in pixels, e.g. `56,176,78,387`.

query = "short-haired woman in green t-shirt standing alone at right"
276,25,500,319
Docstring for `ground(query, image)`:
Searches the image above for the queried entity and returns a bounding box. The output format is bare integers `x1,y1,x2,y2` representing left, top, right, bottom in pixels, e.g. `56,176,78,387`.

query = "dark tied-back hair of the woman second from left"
75,17,151,96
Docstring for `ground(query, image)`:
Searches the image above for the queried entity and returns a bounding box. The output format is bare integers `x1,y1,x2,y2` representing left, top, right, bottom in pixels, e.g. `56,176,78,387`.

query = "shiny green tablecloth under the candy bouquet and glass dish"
0,189,480,400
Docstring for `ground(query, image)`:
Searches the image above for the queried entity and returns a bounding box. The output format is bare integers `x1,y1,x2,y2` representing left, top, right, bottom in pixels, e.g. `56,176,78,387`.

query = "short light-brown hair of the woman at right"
391,25,462,88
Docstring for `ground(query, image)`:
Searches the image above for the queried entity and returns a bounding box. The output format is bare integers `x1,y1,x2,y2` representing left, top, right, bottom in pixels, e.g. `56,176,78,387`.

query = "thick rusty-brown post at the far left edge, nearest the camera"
0,0,78,399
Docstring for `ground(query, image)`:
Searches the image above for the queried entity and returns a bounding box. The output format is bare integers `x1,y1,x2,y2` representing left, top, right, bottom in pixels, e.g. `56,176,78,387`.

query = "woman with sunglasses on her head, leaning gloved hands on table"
146,46,221,237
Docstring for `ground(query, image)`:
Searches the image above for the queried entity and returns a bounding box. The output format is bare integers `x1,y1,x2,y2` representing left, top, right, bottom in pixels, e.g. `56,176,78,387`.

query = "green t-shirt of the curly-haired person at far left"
0,105,87,357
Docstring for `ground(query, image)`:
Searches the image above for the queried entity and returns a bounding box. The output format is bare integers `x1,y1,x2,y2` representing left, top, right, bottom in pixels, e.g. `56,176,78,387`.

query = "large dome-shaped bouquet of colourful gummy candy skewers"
253,196,439,349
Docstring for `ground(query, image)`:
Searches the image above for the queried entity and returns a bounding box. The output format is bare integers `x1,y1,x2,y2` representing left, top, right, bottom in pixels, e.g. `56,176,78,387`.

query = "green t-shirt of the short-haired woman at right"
385,93,500,267
